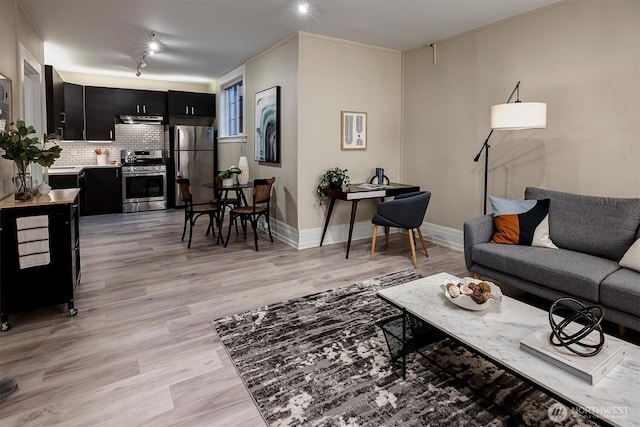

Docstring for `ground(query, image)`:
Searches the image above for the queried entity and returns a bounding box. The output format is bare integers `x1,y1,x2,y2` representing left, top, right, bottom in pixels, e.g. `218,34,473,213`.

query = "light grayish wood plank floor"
0,210,468,427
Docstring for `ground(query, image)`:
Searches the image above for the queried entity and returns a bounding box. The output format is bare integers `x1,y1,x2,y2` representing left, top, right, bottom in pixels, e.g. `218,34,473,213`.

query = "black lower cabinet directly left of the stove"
81,167,122,215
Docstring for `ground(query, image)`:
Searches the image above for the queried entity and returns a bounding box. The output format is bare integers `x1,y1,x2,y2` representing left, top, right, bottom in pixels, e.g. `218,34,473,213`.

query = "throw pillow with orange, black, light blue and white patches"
489,196,558,249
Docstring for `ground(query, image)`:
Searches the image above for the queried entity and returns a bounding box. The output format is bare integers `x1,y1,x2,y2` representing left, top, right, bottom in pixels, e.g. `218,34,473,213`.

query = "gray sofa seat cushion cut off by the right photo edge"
600,268,640,316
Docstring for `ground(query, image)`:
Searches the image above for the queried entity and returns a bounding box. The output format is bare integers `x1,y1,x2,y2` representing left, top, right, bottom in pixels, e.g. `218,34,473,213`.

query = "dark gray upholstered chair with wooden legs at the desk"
369,191,431,268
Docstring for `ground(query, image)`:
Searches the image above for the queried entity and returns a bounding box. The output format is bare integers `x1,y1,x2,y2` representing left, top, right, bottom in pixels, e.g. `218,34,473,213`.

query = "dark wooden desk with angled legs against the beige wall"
320,182,420,258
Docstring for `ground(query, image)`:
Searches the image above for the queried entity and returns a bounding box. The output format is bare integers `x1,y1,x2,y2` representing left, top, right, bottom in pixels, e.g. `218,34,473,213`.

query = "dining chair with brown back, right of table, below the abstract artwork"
224,177,276,251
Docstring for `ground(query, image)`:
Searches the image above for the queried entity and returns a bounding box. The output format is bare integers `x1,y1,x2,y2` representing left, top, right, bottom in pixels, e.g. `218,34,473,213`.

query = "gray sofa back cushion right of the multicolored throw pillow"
525,187,640,261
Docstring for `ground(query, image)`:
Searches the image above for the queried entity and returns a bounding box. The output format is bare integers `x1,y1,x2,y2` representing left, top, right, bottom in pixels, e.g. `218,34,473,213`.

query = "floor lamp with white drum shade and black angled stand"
473,82,547,215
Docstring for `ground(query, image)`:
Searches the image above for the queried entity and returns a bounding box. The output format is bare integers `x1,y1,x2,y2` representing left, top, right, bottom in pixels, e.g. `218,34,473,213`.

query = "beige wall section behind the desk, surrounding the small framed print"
297,33,402,232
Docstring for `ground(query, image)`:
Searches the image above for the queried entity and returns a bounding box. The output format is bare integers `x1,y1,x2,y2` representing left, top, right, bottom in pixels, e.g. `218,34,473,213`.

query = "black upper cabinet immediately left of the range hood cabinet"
84,86,115,141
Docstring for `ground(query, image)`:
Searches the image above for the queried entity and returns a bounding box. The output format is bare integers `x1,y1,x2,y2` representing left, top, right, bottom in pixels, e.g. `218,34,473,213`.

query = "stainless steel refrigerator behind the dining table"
169,125,218,207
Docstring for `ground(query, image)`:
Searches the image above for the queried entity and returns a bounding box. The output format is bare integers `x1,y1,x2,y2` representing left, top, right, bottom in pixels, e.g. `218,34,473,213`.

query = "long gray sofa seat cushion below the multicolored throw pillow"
471,243,620,303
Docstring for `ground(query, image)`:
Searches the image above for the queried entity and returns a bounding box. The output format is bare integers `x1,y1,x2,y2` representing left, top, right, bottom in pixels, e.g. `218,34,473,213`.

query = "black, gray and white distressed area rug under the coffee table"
212,270,594,427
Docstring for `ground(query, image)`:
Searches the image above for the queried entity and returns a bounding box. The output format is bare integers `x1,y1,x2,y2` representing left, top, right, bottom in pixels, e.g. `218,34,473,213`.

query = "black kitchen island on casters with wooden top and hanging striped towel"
0,189,80,331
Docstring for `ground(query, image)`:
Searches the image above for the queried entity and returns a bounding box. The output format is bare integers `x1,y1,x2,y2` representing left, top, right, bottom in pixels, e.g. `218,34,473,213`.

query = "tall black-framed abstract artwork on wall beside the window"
255,86,280,163
